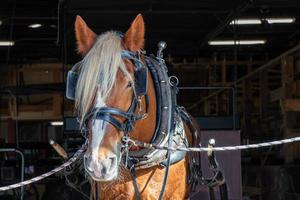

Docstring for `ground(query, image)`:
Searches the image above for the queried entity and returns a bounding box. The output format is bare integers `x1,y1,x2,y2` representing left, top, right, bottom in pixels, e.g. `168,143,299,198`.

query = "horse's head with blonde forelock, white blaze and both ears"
75,15,155,181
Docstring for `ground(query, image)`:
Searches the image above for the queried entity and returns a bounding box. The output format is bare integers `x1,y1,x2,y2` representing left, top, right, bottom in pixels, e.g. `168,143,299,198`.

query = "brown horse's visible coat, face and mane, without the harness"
71,14,199,199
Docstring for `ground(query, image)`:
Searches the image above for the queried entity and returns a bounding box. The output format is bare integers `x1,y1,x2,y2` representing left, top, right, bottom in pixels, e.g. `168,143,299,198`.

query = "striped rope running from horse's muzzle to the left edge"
0,144,86,192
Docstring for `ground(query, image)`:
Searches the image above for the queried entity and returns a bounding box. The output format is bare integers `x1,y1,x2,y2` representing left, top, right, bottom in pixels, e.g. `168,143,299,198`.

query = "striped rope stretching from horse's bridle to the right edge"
131,137,300,152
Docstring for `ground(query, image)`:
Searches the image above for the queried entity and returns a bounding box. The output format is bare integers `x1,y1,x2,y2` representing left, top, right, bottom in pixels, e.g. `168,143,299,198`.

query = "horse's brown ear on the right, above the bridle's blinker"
124,14,145,52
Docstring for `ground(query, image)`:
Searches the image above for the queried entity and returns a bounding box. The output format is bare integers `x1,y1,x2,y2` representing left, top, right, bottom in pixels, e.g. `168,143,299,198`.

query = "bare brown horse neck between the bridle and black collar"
131,69,156,142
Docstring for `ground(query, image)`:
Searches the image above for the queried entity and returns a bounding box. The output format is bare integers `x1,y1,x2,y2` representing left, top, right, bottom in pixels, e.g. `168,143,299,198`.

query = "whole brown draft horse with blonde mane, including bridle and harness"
67,14,200,200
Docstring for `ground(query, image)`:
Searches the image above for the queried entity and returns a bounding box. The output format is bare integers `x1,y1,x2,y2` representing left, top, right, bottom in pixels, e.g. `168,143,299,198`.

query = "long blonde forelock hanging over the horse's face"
75,31,131,124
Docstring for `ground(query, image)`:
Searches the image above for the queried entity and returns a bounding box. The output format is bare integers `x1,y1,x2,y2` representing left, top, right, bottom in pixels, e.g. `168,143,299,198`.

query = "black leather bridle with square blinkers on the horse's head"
67,50,149,166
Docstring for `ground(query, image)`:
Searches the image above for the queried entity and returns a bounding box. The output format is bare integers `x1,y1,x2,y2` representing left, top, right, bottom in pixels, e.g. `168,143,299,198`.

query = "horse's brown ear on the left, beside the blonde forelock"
75,15,97,56
